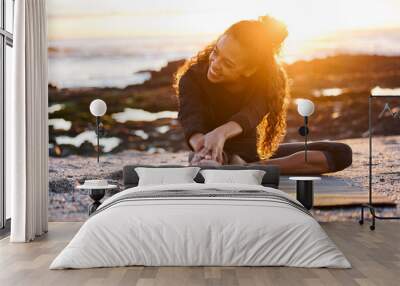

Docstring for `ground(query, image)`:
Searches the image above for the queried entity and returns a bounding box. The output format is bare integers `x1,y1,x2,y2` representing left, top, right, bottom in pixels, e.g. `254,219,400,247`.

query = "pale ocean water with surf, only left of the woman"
49,37,208,88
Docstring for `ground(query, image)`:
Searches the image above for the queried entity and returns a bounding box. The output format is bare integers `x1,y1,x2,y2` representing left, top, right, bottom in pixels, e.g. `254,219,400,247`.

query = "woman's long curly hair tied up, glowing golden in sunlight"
173,16,290,160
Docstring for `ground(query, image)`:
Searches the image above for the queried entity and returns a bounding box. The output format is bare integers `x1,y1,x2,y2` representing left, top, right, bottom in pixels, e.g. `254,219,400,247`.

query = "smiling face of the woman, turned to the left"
207,35,255,83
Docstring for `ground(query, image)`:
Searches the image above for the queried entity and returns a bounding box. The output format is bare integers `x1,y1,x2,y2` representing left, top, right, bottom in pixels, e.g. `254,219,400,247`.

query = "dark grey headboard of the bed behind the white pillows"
122,165,280,189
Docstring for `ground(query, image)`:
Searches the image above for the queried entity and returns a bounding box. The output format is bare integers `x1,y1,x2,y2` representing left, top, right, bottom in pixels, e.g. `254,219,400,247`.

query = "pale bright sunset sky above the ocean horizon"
47,0,400,40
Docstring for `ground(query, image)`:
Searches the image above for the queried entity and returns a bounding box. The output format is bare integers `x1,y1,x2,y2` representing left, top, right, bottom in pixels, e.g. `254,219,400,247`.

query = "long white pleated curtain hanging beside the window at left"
6,0,48,242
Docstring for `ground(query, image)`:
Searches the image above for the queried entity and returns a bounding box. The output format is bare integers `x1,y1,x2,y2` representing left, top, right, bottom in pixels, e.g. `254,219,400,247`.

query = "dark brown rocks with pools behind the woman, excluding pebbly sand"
49,55,400,157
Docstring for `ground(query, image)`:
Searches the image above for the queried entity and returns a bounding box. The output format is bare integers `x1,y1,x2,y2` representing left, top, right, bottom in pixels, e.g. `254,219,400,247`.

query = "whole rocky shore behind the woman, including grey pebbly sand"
49,55,400,221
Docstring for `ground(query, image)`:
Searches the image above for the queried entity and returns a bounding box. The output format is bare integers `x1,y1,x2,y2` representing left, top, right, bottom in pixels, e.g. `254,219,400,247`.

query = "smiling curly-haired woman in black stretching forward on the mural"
174,16,352,174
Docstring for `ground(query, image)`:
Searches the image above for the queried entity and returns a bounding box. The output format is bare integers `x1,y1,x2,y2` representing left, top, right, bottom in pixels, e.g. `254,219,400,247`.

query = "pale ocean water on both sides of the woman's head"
49,28,400,88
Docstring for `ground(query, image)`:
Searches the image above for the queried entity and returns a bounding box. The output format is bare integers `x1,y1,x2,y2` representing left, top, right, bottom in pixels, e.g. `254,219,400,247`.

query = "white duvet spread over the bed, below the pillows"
50,183,351,269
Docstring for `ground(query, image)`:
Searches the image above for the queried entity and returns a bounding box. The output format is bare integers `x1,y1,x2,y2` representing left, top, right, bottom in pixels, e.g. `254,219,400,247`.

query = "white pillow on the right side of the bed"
200,169,265,185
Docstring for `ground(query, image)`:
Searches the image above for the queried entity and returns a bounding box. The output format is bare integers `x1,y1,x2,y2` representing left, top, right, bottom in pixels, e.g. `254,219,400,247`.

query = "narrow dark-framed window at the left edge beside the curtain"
0,0,14,232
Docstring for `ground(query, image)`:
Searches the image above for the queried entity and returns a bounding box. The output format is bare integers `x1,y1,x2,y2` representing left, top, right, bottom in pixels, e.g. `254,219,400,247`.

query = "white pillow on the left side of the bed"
135,167,200,186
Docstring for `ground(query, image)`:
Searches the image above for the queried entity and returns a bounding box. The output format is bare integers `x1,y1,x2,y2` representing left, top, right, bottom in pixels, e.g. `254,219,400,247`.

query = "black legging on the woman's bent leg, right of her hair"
270,141,353,172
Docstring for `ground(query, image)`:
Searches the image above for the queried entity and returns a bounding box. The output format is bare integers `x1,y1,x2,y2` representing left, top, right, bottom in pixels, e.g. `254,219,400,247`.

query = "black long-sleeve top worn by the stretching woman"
178,61,268,162
